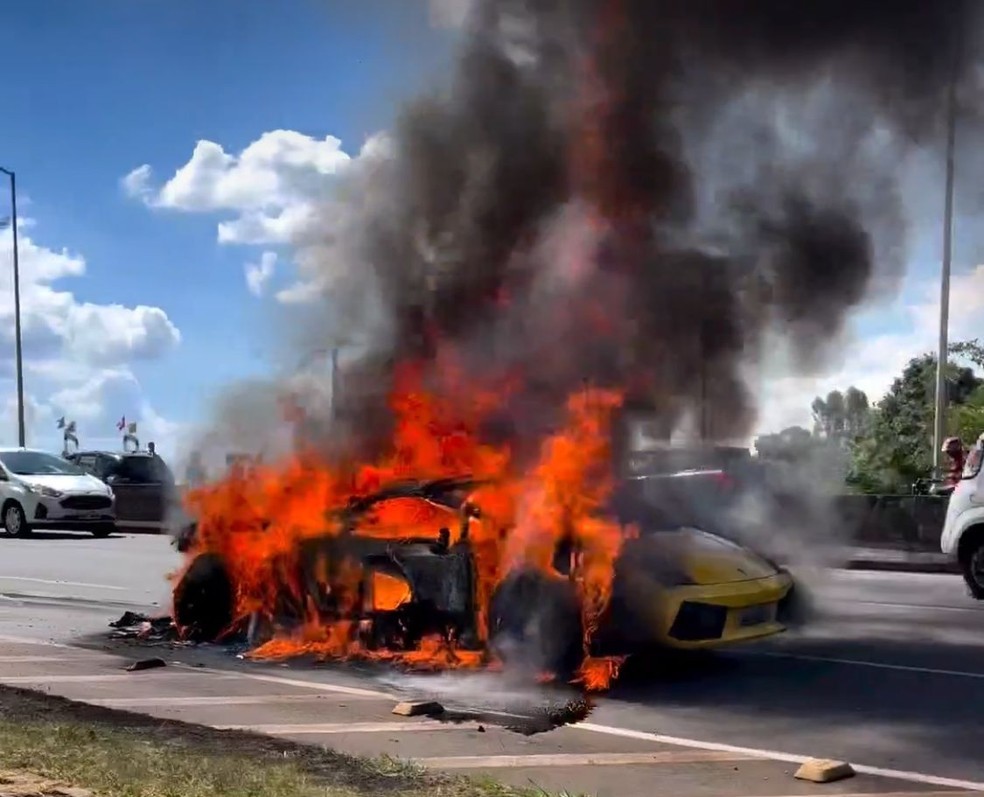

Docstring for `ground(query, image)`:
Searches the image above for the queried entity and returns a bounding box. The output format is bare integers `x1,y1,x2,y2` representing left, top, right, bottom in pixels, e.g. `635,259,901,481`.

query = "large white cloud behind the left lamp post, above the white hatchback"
0,222,181,448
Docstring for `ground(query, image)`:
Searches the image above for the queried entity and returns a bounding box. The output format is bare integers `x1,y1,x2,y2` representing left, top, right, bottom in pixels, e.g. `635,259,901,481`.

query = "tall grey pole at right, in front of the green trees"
933,43,959,478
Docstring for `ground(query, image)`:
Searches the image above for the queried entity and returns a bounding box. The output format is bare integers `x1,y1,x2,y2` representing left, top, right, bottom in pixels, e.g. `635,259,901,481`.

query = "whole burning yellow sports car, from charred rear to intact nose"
175,466,794,688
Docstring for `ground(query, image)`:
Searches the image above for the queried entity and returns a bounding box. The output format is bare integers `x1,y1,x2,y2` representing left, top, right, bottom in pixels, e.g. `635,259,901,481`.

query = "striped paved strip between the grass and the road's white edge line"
0,639,981,797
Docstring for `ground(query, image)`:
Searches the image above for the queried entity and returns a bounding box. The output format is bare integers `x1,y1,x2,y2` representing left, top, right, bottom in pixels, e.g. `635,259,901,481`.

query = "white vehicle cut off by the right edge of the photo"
940,434,984,600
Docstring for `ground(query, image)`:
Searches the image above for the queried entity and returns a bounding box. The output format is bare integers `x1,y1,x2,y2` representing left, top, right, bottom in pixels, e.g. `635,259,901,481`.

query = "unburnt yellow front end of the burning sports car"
626,529,793,649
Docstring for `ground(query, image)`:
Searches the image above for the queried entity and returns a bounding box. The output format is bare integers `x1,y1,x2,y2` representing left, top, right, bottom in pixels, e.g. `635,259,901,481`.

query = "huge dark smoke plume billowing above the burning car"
270,0,981,464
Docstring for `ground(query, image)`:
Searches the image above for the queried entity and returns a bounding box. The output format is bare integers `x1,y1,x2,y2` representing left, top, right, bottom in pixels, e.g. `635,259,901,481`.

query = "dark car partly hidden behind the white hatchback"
66,451,177,531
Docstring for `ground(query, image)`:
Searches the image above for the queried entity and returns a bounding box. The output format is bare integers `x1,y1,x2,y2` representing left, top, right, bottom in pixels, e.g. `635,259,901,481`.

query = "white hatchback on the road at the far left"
0,448,116,537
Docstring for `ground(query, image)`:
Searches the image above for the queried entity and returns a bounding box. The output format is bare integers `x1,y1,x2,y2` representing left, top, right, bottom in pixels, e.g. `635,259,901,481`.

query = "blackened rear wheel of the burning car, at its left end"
174,554,235,642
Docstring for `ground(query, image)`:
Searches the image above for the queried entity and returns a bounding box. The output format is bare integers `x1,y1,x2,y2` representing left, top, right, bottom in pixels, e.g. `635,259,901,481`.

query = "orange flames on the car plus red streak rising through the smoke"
180,2,643,690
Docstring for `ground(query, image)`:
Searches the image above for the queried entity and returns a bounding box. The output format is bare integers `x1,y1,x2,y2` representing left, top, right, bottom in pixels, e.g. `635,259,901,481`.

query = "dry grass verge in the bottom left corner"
0,687,576,797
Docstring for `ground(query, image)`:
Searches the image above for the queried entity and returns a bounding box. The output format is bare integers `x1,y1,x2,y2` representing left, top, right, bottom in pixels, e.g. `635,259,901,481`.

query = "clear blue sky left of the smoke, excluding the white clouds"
0,0,450,454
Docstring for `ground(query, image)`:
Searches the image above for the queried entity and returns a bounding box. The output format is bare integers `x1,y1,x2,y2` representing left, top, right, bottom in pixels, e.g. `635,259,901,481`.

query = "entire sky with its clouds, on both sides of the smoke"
0,0,984,460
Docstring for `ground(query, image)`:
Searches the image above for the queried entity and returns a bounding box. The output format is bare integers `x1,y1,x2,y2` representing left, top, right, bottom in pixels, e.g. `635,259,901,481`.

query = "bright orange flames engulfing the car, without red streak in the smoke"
181,372,631,688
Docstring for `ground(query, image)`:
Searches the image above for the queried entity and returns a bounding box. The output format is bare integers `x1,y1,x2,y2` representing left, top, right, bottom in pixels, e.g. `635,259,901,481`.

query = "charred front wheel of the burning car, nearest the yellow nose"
489,570,584,678
